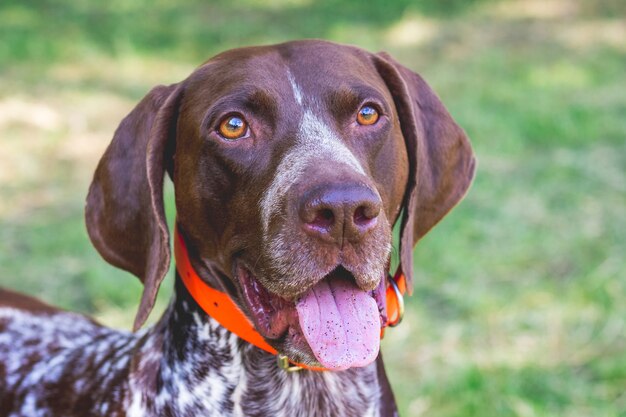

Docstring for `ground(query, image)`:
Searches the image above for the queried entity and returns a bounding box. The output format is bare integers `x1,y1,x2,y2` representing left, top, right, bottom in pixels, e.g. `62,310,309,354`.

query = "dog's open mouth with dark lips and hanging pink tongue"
237,265,387,370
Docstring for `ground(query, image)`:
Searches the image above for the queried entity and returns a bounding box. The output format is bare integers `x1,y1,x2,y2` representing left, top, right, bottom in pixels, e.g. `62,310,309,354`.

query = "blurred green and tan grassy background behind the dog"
0,0,626,417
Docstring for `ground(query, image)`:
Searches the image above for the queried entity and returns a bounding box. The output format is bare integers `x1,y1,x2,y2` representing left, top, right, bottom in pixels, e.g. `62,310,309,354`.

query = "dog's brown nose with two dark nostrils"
298,184,382,245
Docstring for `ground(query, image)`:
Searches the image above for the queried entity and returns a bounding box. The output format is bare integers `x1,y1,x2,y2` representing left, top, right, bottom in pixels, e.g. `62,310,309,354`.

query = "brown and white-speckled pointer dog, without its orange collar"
0,41,474,417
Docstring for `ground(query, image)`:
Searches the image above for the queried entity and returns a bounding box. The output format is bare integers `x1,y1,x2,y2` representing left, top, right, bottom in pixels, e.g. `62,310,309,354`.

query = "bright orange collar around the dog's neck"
174,224,406,371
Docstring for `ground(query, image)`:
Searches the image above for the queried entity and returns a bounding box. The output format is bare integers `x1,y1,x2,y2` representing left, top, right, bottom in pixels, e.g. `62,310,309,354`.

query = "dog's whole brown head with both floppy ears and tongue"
86,41,474,369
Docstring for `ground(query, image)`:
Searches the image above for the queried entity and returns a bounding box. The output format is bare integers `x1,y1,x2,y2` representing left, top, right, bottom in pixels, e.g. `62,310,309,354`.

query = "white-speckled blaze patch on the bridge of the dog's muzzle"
261,106,365,234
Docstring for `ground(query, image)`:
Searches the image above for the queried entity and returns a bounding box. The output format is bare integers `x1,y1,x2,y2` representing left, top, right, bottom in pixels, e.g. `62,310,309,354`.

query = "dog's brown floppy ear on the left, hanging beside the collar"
85,84,182,330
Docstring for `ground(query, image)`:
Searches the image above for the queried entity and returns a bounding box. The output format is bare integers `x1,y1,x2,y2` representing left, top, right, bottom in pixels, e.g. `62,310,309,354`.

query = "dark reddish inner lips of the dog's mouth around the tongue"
236,263,387,344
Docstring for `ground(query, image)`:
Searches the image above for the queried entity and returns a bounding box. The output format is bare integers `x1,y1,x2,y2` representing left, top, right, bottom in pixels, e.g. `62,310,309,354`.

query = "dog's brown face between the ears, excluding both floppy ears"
173,44,408,368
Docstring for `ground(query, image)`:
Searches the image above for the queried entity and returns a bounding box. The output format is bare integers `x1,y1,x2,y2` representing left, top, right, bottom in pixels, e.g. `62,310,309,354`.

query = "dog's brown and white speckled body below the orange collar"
0,276,392,417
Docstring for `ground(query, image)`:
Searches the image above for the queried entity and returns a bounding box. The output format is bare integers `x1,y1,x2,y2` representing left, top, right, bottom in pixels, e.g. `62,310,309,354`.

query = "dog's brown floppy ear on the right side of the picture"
374,53,476,292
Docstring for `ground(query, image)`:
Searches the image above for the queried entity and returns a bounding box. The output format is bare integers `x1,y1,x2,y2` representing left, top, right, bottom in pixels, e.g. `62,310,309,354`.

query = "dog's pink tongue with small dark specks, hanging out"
296,279,380,370
